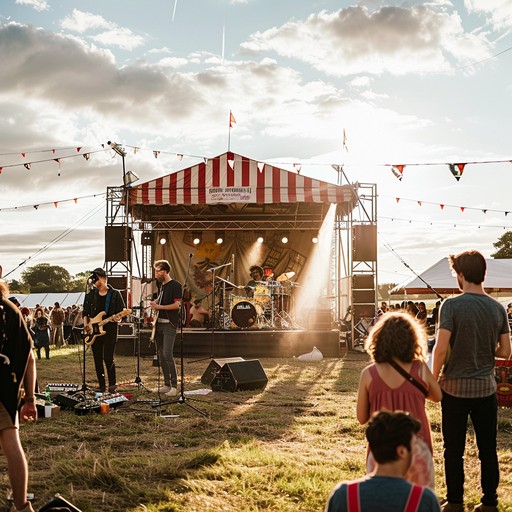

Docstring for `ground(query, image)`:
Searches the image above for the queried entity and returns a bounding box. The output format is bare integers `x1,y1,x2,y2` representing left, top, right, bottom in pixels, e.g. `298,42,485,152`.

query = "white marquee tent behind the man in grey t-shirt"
390,258,512,295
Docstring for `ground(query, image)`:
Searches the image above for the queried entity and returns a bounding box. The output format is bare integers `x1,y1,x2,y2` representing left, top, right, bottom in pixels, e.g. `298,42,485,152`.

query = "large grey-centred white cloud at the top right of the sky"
241,5,489,76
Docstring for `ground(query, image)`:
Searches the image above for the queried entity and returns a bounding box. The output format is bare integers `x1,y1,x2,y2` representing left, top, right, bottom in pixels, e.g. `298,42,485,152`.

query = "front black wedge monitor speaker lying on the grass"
211,359,268,392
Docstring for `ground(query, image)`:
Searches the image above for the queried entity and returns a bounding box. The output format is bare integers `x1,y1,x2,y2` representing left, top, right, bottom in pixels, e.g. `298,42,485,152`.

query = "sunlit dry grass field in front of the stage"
4,347,512,512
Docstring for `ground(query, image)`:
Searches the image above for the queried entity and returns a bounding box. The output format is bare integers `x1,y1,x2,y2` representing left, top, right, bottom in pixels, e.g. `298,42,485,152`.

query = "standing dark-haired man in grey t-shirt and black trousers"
432,251,510,512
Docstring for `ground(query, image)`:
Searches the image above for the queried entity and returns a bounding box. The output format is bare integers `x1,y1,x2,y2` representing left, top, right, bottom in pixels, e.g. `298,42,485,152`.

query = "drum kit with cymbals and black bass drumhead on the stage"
215,271,300,329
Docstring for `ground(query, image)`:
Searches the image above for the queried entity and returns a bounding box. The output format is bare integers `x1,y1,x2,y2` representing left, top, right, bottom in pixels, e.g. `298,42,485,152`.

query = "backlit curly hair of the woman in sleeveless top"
365,312,428,363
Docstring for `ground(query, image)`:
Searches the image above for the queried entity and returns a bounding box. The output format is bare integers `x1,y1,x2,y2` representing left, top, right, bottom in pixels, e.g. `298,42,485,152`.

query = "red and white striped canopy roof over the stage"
130,152,354,205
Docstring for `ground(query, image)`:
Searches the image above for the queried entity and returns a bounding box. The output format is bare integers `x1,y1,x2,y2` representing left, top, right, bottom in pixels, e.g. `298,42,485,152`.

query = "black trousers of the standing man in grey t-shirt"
441,392,500,506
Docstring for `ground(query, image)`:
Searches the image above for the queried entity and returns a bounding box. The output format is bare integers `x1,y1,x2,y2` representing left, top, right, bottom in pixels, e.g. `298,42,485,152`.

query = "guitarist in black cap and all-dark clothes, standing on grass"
83,268,124,393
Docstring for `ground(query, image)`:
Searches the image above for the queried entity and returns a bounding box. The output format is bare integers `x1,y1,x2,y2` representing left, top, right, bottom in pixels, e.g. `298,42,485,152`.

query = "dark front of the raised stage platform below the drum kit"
116,328,340,358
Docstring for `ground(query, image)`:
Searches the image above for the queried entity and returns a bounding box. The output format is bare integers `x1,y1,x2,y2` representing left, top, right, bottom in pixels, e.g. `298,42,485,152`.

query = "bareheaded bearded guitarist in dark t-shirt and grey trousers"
150,260,182,396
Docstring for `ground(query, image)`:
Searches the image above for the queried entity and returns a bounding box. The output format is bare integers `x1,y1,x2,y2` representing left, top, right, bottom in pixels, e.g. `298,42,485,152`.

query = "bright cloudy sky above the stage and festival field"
0,0,512,283
